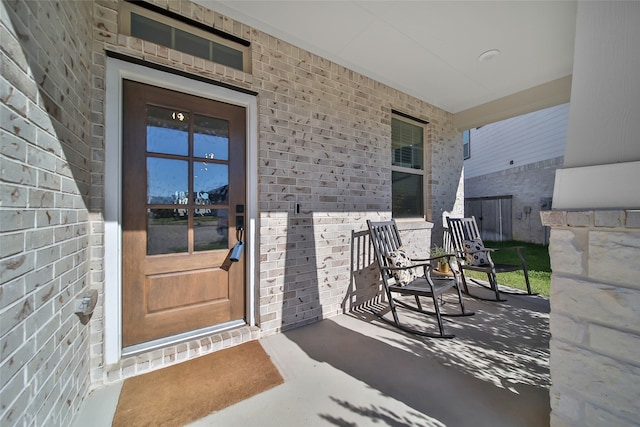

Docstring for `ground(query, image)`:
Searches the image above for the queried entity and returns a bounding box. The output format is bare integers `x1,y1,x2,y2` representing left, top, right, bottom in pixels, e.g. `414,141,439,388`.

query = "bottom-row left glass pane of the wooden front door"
147,209,189,255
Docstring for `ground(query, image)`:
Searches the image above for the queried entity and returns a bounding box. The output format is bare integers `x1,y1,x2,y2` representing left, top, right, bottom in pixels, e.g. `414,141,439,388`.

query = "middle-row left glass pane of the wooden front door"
145,157,189,205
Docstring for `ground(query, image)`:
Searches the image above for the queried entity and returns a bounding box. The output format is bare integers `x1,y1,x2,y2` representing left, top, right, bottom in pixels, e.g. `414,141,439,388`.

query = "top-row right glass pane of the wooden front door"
193,114,229,160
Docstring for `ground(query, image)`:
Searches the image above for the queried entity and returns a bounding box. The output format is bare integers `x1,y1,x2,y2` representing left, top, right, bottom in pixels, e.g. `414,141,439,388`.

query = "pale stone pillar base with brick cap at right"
542,210,640,427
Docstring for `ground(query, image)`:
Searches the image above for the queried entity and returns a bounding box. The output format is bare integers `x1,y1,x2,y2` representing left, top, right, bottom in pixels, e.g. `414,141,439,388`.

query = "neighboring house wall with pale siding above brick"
464,104,569,244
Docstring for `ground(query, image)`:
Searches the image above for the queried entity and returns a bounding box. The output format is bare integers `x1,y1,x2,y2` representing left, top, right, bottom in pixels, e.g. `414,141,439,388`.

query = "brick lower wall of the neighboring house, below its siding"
464,157,563,244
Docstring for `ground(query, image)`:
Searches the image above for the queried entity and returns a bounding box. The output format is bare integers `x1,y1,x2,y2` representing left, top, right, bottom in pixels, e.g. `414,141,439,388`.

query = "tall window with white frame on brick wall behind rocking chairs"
391,116,425,218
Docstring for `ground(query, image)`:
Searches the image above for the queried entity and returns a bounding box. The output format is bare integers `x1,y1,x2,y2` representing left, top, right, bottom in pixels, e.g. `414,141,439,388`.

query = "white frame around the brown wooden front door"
104,58,258,365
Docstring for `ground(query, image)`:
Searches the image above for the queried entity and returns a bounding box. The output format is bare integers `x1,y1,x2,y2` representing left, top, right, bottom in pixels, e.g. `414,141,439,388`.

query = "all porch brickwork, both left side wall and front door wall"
0,1,462,426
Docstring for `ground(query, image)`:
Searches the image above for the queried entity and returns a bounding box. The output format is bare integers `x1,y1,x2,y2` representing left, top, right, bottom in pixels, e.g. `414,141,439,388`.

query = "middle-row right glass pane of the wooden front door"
193,161,229,205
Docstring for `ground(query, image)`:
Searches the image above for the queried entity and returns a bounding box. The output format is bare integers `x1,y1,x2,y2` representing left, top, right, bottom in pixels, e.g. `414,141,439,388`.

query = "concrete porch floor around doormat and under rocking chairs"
76,289,550,427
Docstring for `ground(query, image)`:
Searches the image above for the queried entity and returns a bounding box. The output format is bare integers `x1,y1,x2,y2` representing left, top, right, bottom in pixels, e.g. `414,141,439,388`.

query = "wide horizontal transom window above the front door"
120,2,251,73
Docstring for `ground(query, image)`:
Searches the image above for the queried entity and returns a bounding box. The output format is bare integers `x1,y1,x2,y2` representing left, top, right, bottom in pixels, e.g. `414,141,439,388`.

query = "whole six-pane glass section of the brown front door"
146,105,229,255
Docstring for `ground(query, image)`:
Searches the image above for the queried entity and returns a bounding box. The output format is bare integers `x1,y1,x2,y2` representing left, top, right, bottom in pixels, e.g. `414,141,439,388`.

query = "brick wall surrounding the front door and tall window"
85,0,462,385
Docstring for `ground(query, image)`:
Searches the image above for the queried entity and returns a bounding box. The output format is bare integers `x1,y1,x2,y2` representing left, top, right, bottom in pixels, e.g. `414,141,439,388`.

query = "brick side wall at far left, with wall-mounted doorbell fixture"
0,1,92,426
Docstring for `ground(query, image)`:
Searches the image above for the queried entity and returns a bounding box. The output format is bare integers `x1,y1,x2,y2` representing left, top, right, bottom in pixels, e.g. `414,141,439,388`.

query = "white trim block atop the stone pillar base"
553,161,640,210
